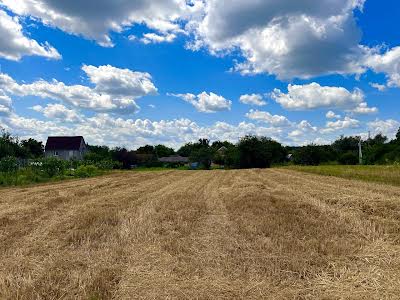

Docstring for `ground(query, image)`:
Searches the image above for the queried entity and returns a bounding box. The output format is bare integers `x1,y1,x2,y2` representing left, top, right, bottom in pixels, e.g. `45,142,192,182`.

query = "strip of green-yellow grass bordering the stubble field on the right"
285,165,400,186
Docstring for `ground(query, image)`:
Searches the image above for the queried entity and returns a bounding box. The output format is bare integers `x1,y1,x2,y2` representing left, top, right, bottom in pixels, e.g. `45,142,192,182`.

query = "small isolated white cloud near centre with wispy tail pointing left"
169,92,232,113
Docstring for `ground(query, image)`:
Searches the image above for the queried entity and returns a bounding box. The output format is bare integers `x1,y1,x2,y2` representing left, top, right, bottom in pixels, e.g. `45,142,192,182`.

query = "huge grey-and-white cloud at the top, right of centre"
189,0,367,79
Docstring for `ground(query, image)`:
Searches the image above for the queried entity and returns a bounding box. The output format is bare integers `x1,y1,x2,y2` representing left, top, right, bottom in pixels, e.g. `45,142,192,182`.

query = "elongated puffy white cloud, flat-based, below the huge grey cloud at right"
271,82,377,113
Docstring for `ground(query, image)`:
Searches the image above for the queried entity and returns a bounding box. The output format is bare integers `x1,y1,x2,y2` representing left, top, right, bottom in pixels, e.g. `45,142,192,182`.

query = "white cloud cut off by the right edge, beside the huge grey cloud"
365,47,400,87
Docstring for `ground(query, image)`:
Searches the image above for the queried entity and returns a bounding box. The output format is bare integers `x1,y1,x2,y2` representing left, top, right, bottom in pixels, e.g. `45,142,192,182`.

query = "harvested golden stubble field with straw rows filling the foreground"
0,169,400,300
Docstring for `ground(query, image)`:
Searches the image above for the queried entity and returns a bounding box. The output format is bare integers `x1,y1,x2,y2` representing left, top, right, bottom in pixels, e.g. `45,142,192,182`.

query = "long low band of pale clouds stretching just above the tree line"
0,106,388,149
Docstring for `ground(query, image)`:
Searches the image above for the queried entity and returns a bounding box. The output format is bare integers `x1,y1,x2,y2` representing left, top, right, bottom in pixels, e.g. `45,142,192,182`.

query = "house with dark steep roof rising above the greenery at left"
44,136,88,160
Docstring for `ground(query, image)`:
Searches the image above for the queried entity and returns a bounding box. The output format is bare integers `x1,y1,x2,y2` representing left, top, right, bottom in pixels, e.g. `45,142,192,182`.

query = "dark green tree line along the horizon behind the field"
0,129,400,172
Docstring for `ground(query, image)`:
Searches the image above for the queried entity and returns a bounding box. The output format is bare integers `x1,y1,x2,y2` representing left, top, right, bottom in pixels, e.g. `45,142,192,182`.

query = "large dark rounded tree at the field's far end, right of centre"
237,135,285,169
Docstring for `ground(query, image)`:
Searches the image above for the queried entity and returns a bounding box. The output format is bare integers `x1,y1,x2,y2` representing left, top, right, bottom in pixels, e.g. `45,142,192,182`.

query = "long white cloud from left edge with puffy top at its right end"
0,65,157,114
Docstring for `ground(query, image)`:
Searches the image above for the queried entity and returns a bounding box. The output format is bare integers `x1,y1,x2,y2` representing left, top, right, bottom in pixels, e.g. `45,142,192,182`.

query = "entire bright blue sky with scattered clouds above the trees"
0,0,400,149
